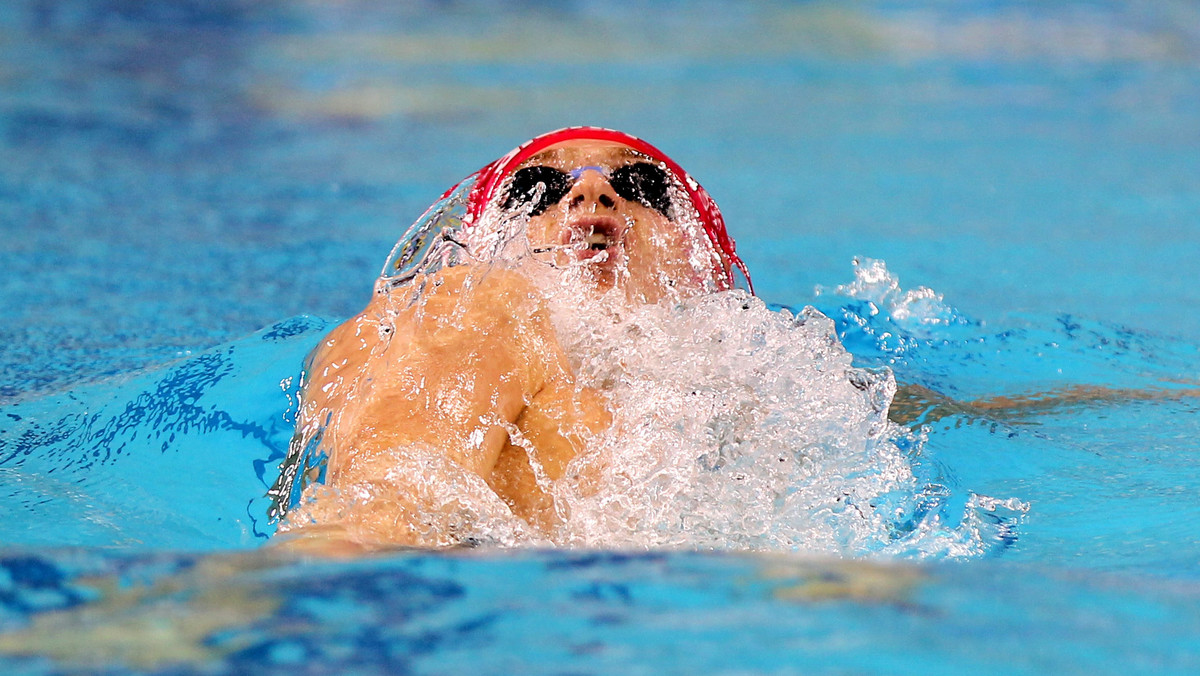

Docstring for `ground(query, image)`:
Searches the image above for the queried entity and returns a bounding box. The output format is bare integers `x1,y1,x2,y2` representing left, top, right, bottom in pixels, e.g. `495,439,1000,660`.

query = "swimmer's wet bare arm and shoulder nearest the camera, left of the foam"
274,268,607,544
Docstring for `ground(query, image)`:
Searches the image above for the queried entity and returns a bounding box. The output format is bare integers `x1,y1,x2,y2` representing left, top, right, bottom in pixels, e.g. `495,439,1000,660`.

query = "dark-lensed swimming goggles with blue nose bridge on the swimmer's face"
504,162,671,217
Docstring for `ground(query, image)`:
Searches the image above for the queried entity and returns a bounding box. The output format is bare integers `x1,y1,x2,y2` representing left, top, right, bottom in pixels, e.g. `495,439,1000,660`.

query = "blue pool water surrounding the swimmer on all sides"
0,0,1200,674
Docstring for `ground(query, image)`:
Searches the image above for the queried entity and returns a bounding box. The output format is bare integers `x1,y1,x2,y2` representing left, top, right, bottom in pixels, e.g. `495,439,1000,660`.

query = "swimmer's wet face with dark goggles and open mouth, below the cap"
506,140,720,303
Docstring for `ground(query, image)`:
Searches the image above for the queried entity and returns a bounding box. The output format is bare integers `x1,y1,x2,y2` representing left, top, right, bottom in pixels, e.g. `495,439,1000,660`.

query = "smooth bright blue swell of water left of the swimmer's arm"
0,316,326,550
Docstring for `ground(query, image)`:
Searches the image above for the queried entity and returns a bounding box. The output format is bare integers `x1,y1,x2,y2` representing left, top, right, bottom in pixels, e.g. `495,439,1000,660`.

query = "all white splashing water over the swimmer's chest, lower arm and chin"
283,213,1025,558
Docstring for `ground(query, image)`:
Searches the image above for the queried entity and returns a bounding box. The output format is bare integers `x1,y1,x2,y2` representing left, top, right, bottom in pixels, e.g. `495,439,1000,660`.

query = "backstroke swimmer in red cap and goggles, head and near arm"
271,127,750,551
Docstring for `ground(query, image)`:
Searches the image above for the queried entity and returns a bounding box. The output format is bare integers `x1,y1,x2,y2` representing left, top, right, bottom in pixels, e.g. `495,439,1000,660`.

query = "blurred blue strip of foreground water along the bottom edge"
0,551,1200,674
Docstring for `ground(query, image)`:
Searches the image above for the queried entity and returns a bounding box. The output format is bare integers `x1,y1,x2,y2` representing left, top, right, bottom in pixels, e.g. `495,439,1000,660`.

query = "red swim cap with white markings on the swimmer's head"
456,127,754,293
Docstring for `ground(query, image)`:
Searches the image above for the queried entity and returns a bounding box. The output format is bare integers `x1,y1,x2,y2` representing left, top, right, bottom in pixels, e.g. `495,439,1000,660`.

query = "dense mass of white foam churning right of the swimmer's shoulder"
535,291,914,555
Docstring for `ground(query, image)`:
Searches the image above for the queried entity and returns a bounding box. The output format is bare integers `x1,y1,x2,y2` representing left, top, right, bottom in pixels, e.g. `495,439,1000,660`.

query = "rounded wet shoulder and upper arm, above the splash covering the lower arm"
321,267,565,477
